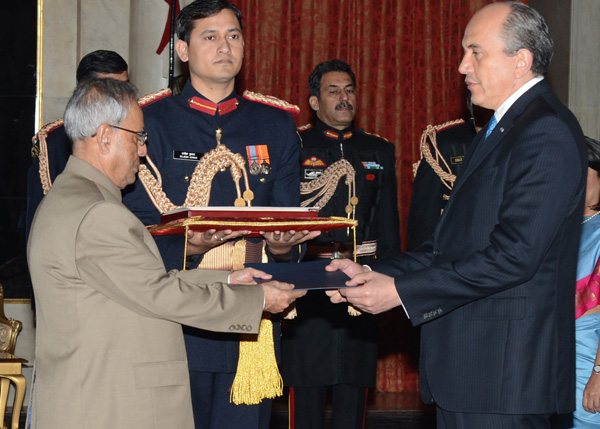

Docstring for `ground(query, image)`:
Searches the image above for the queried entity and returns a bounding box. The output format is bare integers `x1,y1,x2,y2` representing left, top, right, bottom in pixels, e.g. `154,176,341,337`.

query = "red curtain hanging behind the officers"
236,0,524,391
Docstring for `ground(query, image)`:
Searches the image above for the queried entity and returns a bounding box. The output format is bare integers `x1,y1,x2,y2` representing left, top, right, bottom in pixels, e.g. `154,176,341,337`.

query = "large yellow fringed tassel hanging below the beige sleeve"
229,319,283,405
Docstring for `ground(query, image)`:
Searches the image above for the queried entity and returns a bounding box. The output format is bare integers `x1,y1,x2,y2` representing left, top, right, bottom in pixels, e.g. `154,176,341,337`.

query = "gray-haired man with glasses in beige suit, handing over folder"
27,79,305,429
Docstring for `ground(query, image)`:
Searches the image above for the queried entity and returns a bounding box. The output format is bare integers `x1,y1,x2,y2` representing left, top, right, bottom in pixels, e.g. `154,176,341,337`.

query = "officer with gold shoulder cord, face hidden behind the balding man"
406,93,493,250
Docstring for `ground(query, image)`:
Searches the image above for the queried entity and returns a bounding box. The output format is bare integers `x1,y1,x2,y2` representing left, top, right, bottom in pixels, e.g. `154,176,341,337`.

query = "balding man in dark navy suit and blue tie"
328,2,591,429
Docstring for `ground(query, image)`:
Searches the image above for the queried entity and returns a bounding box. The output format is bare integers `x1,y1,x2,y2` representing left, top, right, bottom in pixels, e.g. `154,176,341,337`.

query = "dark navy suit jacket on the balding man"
374,81,591,414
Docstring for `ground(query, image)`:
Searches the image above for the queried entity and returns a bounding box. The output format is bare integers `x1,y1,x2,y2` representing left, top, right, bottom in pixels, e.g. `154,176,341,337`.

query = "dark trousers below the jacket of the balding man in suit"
437,407,551,429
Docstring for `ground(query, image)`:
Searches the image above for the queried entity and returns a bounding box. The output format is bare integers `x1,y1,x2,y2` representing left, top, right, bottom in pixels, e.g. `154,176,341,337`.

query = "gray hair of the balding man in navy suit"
500,1,554,76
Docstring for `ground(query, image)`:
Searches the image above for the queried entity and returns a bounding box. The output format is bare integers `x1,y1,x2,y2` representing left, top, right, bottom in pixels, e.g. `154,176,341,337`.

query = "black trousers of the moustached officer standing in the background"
289,384,369,429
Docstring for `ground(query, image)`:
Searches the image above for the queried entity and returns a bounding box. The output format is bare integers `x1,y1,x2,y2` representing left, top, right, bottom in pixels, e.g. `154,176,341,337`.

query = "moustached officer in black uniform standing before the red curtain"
282,60,400,428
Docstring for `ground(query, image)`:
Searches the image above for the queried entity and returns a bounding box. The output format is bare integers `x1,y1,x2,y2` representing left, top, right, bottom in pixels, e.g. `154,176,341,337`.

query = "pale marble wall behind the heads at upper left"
38,0,169,125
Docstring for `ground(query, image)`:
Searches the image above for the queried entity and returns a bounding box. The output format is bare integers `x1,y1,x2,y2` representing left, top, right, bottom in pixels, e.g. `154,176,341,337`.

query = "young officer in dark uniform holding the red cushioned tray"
123,0,318,429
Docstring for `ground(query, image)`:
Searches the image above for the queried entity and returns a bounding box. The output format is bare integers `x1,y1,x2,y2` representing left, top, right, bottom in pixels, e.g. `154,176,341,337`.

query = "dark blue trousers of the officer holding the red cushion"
190,371,272,429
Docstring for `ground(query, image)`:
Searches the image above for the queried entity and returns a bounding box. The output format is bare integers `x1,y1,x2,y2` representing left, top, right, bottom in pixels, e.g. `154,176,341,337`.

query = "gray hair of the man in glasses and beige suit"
64,79,137,143
